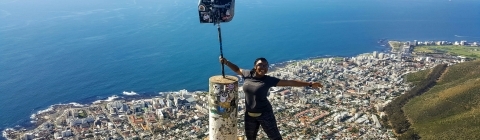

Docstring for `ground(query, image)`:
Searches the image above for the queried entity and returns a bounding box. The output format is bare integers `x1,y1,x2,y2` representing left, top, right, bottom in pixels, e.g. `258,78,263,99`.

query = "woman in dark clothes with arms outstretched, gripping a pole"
220,57,323,140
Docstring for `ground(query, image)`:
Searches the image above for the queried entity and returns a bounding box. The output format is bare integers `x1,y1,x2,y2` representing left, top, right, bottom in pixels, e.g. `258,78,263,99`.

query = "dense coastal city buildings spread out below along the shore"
4,47,468,140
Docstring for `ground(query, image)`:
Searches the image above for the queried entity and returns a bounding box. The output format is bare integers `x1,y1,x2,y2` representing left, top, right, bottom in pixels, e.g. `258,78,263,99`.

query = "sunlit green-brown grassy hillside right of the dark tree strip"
403,61,480,139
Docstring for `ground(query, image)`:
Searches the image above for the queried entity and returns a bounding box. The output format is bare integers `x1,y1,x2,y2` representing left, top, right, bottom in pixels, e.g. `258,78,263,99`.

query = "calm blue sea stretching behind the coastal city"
0,0,480,133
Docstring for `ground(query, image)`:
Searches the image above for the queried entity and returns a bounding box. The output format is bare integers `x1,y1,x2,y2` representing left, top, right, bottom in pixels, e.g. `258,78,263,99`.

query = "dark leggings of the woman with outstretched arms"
245,111,282,140
